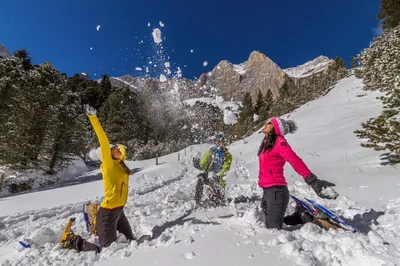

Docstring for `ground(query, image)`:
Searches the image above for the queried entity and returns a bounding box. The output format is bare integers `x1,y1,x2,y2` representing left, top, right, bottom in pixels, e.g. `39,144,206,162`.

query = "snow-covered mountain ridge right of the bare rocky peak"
283,55,335,78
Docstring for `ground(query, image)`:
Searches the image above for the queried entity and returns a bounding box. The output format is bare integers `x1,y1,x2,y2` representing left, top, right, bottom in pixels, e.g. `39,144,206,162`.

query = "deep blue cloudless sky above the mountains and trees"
0,0,379,78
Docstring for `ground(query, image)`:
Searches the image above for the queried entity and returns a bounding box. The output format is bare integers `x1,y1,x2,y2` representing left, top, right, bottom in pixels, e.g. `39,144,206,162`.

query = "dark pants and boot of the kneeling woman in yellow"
74,207,135,253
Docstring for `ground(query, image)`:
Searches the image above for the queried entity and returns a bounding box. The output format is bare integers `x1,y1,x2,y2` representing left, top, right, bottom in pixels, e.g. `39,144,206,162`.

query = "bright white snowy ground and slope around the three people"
0,77,400,266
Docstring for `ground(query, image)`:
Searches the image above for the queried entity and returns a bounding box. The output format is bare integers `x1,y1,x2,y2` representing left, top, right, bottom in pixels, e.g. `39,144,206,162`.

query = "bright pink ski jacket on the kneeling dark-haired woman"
258,135,312,188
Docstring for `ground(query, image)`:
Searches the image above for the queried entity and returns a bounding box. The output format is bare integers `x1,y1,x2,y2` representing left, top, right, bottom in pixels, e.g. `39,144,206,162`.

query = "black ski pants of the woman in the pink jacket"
261,186,289,230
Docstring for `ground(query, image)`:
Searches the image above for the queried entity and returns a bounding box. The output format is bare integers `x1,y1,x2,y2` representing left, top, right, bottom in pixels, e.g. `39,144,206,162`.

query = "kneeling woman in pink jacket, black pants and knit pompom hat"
258,117,335,229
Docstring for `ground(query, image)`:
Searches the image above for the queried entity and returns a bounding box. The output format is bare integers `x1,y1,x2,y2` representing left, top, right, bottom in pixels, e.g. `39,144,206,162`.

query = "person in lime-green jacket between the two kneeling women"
195,132,232,205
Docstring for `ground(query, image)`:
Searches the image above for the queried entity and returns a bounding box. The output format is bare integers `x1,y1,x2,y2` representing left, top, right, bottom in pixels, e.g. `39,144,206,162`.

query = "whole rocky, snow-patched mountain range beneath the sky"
103,51,341,104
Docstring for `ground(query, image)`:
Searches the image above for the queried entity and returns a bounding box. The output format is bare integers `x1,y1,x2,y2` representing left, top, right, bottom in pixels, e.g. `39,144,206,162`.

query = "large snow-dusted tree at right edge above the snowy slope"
355,26,400,162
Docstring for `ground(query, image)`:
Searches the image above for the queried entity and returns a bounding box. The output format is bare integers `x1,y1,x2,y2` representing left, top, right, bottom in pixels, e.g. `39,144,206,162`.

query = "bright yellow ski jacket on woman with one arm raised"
88,115,129,209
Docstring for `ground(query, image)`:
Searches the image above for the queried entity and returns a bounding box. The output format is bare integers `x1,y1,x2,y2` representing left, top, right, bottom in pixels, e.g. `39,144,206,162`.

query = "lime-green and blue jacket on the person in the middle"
200,147,232,176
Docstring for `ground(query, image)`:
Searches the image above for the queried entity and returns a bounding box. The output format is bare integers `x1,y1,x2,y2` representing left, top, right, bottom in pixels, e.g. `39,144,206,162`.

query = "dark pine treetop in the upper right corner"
378,0,400,31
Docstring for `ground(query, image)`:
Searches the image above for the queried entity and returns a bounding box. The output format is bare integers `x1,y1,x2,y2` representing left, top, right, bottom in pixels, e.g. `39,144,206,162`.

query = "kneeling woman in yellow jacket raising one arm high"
63,106,135,252
